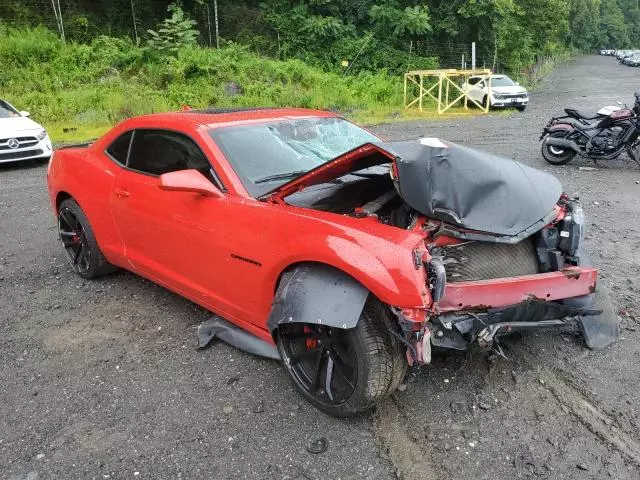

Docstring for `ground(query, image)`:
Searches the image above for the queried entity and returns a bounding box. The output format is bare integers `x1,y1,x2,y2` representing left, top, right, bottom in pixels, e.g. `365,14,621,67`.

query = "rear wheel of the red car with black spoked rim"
58,198,116,279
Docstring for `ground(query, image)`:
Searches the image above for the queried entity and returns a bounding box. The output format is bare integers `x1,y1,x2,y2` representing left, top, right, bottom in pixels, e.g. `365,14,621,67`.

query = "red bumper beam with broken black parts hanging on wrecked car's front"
410,267,619,364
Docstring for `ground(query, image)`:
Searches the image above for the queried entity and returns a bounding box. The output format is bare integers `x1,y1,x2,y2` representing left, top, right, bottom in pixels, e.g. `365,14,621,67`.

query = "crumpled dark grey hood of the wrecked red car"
377,138,562,236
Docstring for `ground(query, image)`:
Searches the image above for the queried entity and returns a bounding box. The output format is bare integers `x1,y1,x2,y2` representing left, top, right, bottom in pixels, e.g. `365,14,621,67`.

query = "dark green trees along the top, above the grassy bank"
5,0,640,78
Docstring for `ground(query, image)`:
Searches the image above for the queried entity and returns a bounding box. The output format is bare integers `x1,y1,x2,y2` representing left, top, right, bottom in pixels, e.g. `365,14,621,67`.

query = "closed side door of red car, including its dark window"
110,129,241,313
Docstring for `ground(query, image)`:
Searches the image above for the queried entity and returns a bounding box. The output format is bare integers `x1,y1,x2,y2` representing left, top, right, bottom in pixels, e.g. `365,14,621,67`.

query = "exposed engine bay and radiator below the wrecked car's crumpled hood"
287,159,584,282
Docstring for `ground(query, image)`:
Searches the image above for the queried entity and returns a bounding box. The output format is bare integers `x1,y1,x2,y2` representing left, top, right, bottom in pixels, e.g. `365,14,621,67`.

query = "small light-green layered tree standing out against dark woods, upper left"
147,3,199,53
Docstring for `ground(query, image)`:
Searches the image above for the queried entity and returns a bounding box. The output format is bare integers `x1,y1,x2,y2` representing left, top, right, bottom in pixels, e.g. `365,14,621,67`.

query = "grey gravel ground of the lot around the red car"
0,57,640,480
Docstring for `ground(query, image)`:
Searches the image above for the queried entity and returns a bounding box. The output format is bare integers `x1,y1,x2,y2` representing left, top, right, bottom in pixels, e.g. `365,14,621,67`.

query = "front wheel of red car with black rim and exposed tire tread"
277,297,407,417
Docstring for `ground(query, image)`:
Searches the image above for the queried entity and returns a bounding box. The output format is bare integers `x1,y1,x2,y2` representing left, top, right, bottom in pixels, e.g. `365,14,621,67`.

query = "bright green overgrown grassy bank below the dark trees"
0,24,520,144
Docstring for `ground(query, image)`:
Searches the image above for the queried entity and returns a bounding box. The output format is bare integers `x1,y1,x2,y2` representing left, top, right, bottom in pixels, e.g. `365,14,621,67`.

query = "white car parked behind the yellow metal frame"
462,75,529,112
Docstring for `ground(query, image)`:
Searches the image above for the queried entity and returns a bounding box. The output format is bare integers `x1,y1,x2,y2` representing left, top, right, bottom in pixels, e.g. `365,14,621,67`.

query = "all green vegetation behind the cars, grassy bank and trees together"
0,0,640,144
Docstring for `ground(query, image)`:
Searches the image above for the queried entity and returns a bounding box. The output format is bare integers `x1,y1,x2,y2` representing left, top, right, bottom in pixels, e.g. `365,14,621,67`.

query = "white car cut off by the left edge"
0,99,52,163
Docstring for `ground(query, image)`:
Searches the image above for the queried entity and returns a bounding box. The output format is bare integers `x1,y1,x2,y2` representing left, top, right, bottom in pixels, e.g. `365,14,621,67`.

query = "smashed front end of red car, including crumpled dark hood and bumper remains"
286,139,617,363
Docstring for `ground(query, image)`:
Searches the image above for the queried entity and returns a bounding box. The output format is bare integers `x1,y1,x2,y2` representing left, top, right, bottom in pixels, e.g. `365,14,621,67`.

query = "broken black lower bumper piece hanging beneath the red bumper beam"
431,299,618,350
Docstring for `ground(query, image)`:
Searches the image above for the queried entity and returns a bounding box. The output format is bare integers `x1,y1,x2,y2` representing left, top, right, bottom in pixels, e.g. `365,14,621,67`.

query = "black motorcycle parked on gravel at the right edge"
540,92,640,165
